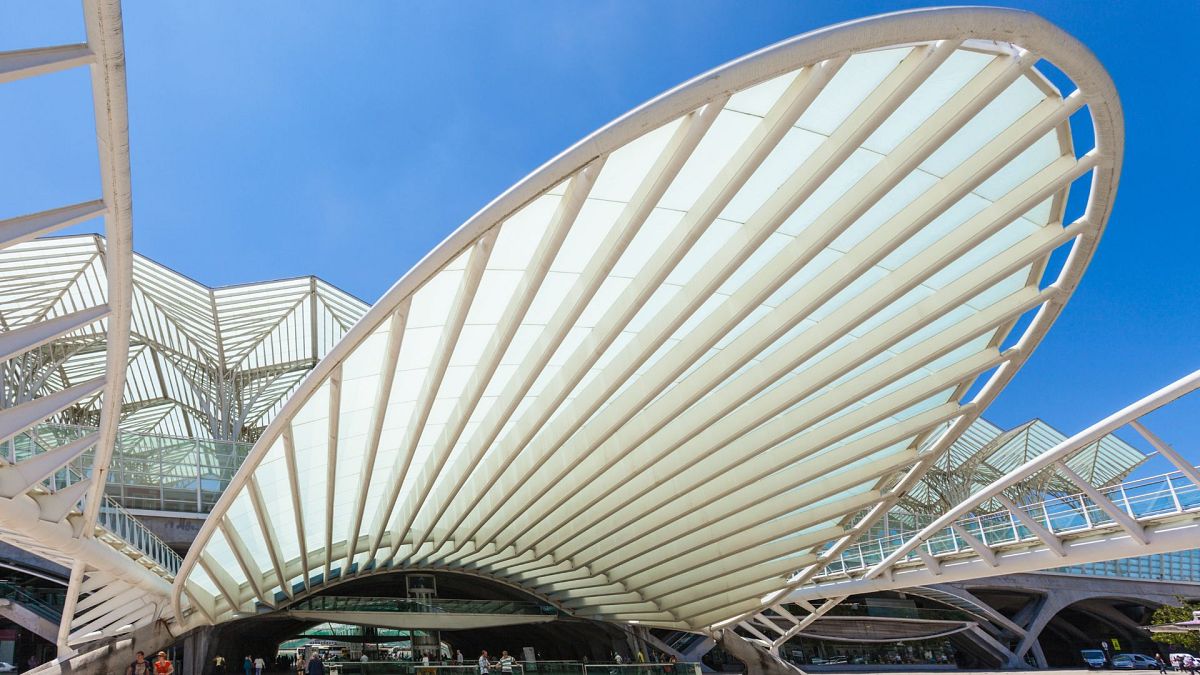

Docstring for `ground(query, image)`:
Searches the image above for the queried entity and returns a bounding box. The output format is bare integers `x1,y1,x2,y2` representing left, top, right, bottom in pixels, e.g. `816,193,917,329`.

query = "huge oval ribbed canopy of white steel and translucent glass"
174,8,1122,629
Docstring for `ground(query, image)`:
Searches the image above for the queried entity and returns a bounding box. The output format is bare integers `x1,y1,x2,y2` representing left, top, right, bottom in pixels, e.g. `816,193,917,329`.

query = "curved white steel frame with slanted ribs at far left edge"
0,0,181,653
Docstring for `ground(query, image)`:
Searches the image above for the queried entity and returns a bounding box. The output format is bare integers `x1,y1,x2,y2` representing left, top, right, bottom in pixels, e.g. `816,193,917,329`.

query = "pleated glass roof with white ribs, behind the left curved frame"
0,234,366,441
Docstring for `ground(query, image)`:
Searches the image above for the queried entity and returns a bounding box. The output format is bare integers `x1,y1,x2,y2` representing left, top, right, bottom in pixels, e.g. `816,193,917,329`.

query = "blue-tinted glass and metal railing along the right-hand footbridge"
814,471,1200,579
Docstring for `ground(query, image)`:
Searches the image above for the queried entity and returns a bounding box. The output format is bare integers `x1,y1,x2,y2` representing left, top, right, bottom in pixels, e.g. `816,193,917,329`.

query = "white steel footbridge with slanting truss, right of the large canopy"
784,371,1200,602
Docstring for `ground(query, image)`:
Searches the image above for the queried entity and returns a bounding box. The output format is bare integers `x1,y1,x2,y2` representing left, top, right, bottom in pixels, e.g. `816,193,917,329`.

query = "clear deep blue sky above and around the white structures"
0,0,1200,468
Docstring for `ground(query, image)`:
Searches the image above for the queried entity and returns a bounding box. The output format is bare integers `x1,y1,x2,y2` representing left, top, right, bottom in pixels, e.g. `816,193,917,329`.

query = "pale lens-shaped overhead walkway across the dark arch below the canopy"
281,596,559,631
